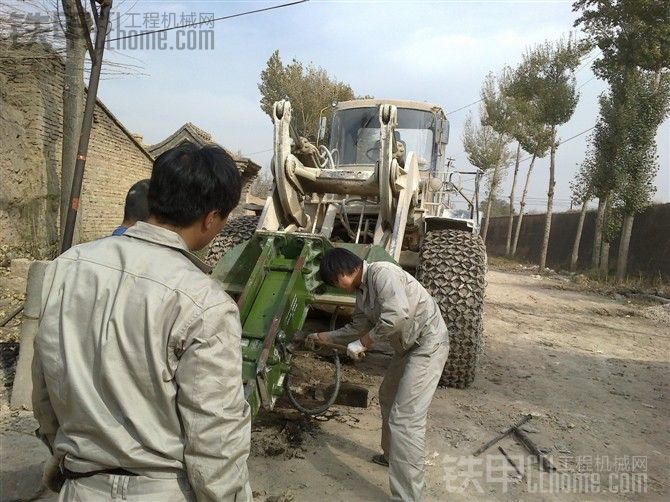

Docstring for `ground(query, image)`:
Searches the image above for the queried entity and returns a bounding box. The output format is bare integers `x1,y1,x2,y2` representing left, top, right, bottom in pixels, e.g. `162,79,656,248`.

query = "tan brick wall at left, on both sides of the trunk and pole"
0,45,152,257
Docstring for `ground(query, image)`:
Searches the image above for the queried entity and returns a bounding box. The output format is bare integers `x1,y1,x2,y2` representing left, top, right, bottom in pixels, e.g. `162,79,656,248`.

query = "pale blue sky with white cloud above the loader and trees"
47,0,670,210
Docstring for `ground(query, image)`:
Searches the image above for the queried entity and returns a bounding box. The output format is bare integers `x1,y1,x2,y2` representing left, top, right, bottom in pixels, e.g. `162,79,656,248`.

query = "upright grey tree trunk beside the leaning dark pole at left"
60,0,86,242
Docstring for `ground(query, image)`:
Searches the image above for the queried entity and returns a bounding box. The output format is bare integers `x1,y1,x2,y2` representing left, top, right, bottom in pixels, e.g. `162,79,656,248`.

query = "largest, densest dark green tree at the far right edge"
573,0,670,279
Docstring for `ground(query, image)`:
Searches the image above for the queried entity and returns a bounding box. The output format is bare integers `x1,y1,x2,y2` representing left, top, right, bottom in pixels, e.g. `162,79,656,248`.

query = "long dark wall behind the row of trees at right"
486,204,670,278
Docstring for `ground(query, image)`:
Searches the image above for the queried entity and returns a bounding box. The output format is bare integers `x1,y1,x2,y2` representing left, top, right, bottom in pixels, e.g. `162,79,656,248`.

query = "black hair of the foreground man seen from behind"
149,142,242,227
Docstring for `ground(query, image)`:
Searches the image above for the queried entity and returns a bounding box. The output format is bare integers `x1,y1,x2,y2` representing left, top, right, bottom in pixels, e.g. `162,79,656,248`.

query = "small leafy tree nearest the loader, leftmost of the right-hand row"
463,109,511,241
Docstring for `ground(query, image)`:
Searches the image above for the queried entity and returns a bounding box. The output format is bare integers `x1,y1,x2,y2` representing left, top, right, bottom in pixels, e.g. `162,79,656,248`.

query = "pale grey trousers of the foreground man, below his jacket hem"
58,474,196,502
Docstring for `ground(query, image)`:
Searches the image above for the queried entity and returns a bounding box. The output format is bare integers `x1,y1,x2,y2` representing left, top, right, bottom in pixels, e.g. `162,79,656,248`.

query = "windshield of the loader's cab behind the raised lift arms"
330,107,435,169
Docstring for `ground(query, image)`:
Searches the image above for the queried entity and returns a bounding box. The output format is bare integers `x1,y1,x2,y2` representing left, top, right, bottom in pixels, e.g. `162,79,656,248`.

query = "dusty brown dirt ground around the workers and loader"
0,264,670,501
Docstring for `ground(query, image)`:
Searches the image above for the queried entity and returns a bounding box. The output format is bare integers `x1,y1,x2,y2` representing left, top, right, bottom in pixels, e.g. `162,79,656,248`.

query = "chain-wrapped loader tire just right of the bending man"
416,230,486,389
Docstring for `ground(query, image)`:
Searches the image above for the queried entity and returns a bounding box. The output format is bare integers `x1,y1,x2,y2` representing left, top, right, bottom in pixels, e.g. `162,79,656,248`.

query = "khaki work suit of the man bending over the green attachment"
328,262,449,501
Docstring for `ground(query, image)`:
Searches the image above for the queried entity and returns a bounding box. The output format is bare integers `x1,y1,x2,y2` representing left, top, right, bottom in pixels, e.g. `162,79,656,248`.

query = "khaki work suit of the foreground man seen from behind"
33,222,251,502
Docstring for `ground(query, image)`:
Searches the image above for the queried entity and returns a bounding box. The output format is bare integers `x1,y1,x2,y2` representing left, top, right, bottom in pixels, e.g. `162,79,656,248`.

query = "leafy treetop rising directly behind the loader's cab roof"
258,50,354,140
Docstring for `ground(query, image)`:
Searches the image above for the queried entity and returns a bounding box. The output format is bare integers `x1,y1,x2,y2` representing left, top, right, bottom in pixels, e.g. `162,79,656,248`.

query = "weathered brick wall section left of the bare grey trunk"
0,47,62,256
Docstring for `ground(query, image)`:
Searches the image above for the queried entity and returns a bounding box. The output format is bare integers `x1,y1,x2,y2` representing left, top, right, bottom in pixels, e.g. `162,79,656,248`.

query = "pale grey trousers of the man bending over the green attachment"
379,342,449,502
